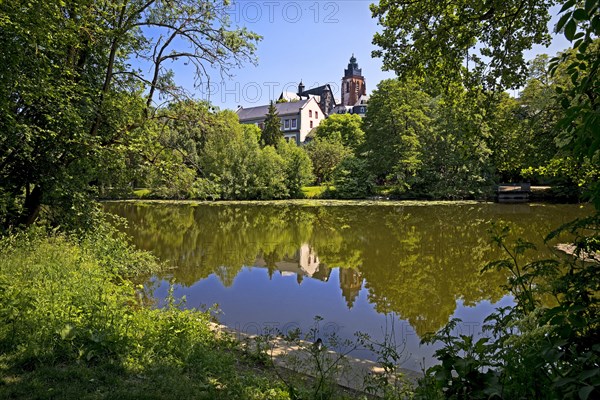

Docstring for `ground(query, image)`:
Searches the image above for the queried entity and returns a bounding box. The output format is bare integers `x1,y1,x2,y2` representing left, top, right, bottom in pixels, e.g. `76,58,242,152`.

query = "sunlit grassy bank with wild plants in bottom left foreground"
0,231,289,399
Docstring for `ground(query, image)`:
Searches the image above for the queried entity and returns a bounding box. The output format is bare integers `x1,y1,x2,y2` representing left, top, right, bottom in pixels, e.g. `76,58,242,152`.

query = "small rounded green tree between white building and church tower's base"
316,114,365,152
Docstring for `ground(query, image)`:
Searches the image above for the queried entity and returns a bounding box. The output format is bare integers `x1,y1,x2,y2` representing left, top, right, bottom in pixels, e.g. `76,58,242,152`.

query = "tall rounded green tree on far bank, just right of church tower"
364,79,431,185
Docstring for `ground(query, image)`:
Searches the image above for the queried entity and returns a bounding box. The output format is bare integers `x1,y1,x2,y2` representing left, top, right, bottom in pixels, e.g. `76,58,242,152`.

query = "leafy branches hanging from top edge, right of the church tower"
371,0,556,89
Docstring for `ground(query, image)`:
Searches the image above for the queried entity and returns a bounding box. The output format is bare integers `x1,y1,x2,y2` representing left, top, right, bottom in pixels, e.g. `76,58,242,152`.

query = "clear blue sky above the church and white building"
166,0,568,110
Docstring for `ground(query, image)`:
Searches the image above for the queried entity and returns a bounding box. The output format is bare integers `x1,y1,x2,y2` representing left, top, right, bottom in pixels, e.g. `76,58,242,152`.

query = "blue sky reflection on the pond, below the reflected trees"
155,267,512,371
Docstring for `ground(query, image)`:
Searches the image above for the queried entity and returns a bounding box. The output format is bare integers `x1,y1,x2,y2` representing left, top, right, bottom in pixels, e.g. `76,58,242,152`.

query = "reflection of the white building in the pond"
254,243,331,284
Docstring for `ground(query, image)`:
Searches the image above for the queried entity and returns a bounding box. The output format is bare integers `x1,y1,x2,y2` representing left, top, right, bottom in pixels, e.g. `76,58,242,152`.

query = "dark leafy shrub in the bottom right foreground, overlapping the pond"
417,220,600,399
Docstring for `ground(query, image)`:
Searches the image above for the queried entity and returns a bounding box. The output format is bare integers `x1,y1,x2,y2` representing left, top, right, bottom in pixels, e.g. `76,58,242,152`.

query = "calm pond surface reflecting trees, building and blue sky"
105,202,592,370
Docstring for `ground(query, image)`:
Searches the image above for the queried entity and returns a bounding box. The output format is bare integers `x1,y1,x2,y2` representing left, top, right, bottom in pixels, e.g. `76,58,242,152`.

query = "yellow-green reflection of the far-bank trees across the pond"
106,203,585,334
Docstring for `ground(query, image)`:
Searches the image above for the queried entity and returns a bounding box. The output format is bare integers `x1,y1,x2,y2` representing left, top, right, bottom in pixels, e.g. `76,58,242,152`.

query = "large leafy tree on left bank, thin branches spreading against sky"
0,0,259,228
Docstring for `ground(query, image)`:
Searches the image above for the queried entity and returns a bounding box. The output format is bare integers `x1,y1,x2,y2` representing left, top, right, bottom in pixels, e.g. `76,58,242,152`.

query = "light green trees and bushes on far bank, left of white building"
134,101,312,200
